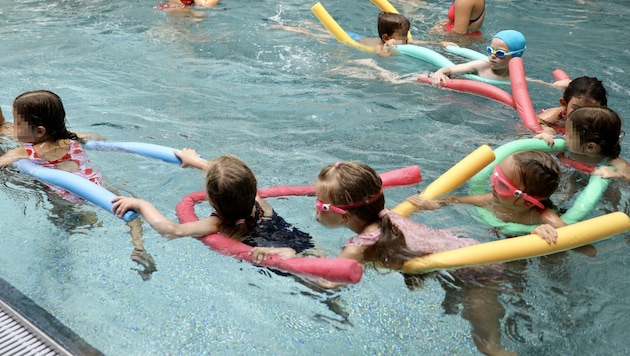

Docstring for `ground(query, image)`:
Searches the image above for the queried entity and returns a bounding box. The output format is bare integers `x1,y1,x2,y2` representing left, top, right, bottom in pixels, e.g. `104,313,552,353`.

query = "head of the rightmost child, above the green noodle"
564,106,623,158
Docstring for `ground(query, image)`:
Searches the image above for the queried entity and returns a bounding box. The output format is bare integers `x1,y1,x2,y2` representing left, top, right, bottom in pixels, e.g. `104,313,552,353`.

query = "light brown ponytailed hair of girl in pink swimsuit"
317,162,419,269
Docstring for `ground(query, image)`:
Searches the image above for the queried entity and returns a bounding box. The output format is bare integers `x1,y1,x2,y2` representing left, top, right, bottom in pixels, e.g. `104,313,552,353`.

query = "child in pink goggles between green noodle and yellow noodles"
407,151,566,243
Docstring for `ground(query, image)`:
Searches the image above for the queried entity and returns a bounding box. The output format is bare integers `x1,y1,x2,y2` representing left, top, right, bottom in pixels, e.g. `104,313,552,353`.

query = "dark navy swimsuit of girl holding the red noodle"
230,202,314,253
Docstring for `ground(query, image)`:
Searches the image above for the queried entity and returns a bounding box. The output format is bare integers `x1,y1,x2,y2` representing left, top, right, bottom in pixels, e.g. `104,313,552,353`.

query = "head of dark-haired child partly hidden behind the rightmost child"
560,76,608,116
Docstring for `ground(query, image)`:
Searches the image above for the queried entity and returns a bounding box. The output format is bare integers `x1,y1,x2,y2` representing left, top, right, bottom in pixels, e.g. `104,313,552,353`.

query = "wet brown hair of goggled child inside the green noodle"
512,150,560,206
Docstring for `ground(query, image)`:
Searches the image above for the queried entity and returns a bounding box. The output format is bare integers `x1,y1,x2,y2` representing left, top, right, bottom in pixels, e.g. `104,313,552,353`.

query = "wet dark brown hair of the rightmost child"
567,107,624,158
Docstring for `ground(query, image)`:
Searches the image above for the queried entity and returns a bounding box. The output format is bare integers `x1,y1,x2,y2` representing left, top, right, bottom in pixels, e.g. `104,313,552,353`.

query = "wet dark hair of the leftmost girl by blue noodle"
13,90,84,143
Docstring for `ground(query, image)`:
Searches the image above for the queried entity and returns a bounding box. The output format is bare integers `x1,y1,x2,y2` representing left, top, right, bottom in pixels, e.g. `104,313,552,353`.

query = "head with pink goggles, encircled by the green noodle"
490,150,560,209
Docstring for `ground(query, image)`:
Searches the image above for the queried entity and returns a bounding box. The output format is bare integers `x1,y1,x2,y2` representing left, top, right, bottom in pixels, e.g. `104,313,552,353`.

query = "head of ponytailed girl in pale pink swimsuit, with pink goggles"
315,162,385,227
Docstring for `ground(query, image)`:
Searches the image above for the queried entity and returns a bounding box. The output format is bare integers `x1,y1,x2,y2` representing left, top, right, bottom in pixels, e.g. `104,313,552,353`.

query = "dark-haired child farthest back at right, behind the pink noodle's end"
534,76,608,145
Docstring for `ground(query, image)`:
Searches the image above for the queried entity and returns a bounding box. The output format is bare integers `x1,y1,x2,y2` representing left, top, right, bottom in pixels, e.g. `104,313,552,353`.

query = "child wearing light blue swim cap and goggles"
431,30,527,86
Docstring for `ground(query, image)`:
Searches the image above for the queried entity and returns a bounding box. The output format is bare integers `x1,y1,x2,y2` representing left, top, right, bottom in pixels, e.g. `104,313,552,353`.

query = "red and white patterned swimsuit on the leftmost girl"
24,140,102,204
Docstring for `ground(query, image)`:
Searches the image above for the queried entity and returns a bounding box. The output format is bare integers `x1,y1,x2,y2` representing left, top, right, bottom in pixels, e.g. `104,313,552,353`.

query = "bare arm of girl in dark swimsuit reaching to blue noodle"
112,196,218,238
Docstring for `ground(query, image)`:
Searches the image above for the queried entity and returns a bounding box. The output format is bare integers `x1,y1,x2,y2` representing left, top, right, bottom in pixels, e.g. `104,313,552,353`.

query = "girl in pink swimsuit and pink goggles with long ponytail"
308,162,510,355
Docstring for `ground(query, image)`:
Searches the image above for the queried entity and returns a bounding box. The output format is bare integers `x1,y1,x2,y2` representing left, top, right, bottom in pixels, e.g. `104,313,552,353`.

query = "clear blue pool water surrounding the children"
0,0,630,355
